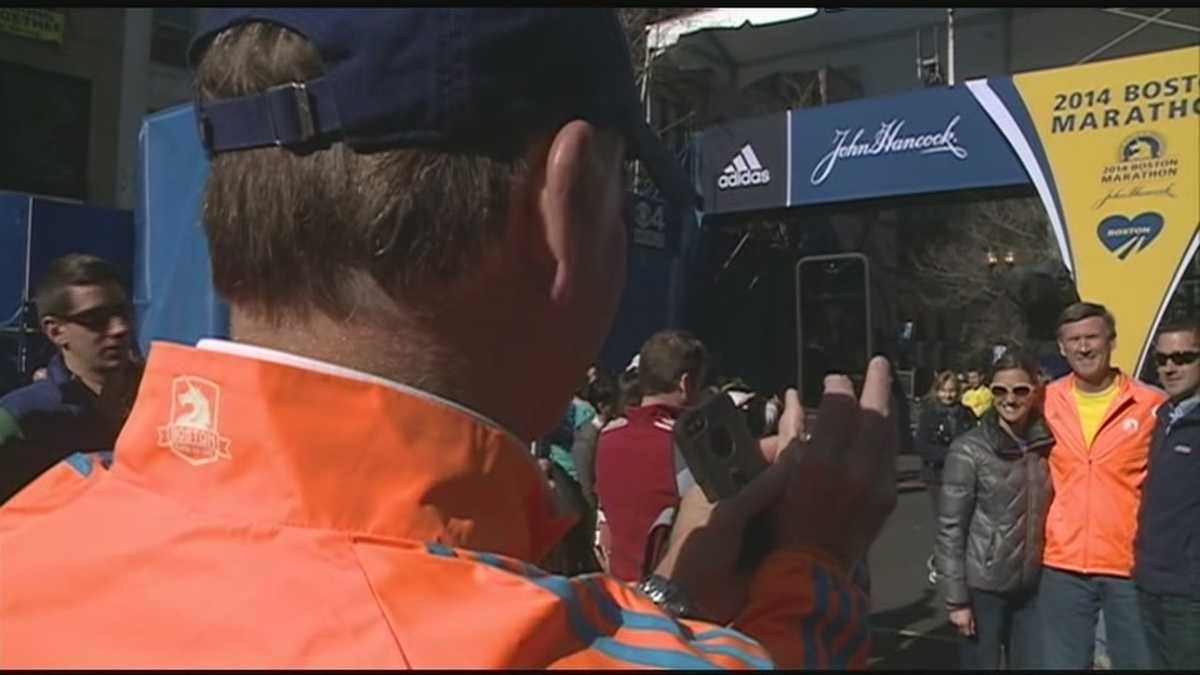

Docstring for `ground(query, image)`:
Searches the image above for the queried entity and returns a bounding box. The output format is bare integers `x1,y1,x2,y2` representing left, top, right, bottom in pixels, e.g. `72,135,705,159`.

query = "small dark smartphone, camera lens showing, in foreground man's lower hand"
674,394,767,502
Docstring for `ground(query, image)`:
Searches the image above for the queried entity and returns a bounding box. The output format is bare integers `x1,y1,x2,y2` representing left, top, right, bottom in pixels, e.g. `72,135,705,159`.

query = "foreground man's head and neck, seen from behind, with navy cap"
190,7,694,438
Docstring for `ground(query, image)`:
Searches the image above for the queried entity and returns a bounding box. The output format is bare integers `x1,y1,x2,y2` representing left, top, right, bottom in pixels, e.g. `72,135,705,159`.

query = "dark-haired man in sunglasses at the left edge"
0,253,136,502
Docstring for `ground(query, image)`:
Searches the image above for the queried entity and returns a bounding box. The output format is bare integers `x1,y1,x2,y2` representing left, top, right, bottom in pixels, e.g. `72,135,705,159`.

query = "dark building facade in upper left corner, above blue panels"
0,7,198,209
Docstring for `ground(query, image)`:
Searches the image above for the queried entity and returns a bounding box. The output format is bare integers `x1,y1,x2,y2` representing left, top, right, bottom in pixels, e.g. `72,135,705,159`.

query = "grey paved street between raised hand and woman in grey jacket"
870,455,958,670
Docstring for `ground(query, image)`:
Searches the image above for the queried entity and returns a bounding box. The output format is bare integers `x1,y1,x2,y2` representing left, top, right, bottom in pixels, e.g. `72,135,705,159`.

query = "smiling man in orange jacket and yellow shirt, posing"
1038,303,1166,669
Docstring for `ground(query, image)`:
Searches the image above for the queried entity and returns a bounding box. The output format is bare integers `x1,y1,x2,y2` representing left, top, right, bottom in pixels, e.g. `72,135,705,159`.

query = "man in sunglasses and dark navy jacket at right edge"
1134,318,1200,670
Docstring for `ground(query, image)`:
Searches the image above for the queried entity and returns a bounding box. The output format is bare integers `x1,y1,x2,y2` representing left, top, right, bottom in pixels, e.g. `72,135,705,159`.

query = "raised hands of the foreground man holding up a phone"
655,358,898,623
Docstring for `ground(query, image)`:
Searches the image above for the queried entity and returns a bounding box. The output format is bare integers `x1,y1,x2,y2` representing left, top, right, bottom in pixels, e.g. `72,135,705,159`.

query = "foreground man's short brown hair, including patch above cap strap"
196,23,528,321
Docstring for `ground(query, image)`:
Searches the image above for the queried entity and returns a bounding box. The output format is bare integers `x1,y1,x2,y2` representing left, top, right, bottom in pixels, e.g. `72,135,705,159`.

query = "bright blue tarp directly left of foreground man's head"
133,104,229,353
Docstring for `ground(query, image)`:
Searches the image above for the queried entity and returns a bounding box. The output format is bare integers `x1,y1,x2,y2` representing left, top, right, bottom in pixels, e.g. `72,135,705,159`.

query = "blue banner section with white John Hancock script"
787,86,1030,205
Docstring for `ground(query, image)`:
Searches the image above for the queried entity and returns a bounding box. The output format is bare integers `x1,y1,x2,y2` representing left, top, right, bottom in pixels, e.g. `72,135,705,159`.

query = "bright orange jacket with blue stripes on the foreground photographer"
0,344,870,669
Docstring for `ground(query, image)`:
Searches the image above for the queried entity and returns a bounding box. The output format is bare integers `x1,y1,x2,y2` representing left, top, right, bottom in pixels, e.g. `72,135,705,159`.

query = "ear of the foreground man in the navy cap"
538,120,608,303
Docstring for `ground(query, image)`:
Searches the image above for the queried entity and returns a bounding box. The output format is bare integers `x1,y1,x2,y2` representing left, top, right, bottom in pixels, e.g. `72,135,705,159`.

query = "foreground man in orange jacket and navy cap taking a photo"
0,8,896,669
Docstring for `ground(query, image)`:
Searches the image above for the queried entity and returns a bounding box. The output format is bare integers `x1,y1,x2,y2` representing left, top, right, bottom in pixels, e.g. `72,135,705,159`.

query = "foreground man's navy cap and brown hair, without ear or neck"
190,8,692,326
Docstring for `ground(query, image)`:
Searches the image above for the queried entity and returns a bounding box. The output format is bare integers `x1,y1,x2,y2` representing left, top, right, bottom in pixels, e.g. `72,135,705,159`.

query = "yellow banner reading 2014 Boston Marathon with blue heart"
967,47,1200,374
